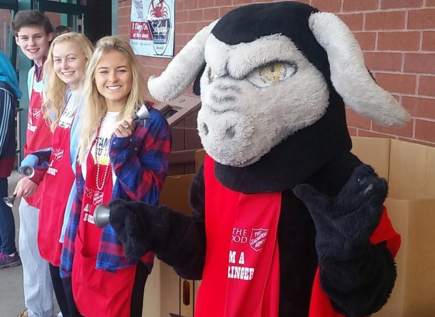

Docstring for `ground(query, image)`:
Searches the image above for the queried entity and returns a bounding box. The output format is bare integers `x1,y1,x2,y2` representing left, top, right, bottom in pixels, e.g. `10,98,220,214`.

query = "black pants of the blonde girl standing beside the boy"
50,264,83,317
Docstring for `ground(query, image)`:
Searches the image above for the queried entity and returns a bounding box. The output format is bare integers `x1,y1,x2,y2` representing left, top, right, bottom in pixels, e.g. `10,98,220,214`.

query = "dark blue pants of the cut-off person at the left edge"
0,177,17,255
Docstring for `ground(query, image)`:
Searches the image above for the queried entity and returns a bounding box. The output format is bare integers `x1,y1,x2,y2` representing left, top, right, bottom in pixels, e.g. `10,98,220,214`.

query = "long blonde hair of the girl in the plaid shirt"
79,36,149,163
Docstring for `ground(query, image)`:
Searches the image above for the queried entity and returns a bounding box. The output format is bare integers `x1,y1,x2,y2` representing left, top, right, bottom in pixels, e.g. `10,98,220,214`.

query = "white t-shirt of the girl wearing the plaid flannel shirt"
82,112,119,186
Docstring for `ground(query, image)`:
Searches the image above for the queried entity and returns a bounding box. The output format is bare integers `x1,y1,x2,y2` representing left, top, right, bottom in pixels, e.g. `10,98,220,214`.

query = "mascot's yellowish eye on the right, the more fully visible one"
246,63,298,88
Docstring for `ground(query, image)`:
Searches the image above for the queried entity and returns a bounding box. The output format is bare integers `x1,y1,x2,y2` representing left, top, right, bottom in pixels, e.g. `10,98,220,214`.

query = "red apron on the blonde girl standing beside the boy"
38,102,75,266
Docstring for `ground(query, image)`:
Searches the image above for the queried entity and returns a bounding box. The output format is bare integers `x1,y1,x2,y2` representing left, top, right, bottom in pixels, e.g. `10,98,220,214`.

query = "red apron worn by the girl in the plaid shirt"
72,141,137,317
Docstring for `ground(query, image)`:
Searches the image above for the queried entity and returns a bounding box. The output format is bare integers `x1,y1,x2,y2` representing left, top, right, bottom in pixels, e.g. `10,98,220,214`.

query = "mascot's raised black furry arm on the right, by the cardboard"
294,165,396,317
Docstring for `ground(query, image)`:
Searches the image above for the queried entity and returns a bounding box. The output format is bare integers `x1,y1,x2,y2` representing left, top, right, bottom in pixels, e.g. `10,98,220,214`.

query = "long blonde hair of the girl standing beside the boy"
42,32,94,132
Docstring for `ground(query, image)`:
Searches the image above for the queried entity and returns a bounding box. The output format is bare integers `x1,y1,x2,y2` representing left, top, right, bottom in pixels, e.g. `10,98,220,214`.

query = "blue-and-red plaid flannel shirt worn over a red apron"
60,105,171,277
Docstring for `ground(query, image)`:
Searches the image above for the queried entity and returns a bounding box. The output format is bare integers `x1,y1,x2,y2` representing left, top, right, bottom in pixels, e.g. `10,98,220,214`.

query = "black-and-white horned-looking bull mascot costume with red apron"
110,1,409,317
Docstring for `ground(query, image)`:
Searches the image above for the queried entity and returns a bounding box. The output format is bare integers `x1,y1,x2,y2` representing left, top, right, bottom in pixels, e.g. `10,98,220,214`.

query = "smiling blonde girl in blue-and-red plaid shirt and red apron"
61,37,171,317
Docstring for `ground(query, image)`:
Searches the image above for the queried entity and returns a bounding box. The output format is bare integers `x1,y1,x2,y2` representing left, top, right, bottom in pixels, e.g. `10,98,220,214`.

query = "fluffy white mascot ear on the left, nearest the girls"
148,21,217,101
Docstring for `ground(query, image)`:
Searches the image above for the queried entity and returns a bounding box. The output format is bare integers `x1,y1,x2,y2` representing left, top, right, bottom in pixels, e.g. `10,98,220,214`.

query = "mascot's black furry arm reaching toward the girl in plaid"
109,168,206,279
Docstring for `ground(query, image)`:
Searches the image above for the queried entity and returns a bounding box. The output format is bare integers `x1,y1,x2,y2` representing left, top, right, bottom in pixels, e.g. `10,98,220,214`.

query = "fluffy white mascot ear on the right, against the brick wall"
309,12,410,126
